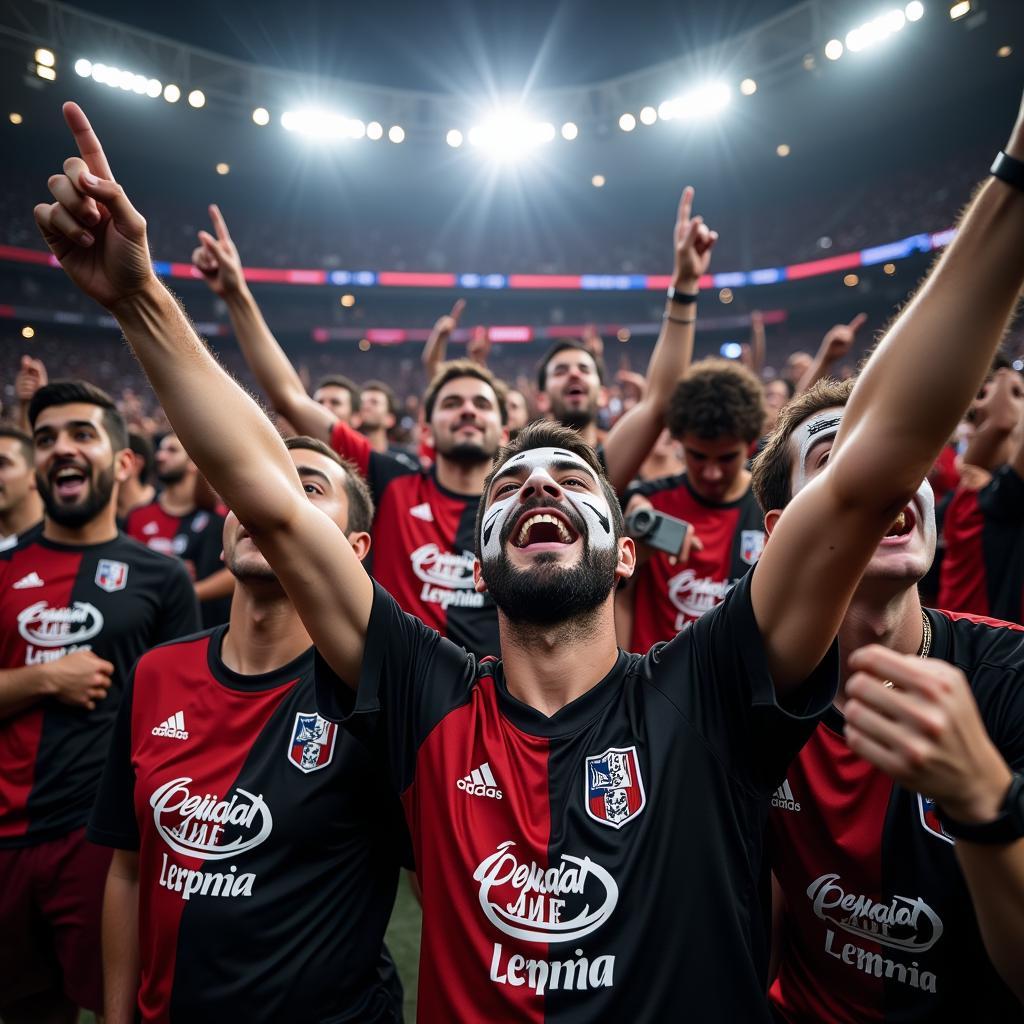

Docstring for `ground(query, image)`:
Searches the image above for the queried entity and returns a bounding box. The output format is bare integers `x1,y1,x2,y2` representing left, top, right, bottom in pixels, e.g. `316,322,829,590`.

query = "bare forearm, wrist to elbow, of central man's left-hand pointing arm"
111,282,305,529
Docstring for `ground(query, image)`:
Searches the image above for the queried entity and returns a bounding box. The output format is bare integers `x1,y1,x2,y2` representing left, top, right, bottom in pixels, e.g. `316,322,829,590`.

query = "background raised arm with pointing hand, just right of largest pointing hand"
193,205,337,442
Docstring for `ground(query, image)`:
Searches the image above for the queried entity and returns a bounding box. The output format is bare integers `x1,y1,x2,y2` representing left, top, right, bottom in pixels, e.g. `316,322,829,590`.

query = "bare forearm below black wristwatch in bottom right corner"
956,840,1024,1002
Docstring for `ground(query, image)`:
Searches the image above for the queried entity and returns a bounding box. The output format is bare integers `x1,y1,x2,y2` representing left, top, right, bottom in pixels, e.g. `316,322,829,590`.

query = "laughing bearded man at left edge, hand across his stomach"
0,381,199,1024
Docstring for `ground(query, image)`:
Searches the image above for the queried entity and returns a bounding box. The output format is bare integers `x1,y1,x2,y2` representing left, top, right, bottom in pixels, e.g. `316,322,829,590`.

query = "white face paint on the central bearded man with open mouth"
480,447,615,561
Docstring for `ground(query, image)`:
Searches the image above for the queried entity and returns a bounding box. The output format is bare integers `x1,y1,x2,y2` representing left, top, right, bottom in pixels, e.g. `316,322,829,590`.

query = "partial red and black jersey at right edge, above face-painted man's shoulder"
938,466,1024,623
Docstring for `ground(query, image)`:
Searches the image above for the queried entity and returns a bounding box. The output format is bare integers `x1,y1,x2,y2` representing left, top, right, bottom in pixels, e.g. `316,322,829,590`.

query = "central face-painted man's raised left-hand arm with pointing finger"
35,103,373,686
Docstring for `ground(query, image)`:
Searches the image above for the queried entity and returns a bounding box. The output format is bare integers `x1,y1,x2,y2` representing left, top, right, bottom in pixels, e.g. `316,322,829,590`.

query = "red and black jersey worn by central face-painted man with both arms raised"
316,578,838,1024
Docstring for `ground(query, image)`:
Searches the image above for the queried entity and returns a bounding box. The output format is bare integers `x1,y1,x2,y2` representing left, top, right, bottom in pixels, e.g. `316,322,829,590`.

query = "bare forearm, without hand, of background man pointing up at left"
224,286,334,437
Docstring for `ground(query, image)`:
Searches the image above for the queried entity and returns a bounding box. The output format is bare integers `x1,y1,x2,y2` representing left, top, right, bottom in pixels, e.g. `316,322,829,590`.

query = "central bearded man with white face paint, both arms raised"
35,97,1024,1024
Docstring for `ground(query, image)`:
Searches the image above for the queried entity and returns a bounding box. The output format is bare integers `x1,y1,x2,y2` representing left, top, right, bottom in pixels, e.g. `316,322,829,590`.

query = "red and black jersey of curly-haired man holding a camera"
627,473,765,653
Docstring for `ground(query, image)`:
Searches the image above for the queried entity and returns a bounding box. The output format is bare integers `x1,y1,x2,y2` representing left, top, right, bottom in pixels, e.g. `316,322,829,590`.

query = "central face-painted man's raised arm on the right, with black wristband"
752,94,1024,694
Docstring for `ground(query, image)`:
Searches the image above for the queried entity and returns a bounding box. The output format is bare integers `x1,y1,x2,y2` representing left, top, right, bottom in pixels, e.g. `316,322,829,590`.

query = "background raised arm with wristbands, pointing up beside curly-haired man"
604,185,718,494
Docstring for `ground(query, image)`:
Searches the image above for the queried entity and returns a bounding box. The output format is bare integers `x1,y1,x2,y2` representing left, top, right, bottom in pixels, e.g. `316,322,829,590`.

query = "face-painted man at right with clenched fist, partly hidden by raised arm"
753,380,1024,1024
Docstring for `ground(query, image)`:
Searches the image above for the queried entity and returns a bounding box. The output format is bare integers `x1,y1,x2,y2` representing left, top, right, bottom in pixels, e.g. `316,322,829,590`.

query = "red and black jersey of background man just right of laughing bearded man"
125,498,231,629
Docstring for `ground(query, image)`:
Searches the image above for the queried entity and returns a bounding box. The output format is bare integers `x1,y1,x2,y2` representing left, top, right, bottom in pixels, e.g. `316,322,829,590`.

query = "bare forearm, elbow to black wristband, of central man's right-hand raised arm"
833,173,1024,505
